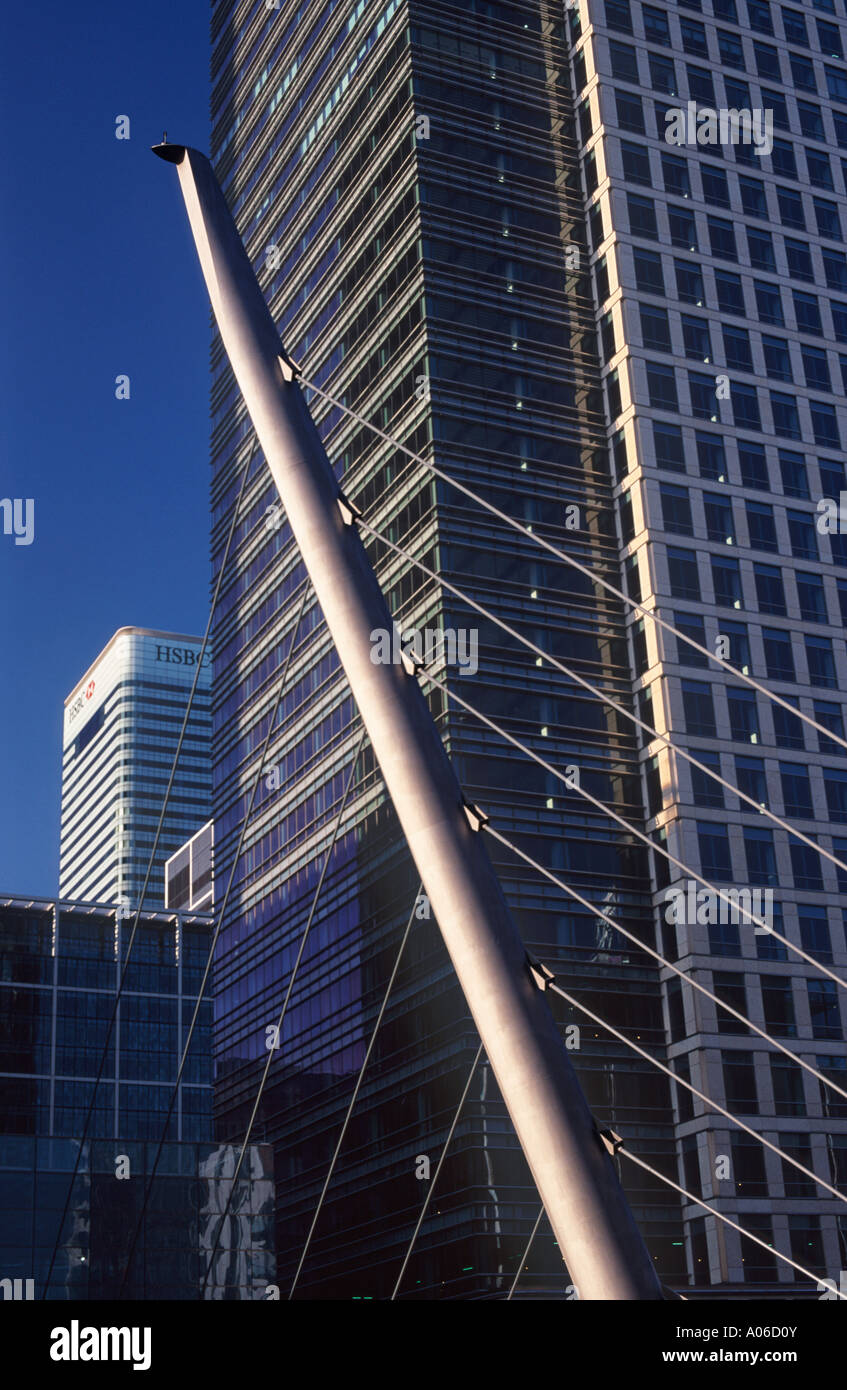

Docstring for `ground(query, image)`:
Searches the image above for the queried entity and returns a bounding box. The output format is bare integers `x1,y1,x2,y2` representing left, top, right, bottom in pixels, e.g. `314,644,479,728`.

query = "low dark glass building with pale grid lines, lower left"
0,897,273,1298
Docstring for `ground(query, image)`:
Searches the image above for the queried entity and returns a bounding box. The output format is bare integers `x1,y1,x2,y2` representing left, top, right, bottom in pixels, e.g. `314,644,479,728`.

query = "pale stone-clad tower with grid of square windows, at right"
573,0,847,1294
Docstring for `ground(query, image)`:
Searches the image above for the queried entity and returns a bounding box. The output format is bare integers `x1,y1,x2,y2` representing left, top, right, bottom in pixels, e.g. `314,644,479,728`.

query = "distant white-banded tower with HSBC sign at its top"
60,627,211,908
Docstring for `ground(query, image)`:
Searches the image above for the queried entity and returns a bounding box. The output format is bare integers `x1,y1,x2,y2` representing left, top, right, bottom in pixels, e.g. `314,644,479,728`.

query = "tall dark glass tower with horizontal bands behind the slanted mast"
211,0,686,1298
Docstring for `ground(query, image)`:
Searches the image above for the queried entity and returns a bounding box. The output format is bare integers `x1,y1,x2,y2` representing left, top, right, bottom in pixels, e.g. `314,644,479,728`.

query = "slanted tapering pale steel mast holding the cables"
154,145,662,1300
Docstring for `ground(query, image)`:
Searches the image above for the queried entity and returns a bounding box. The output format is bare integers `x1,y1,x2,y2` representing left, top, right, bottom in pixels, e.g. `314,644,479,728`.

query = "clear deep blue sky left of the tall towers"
0,0,210,895
